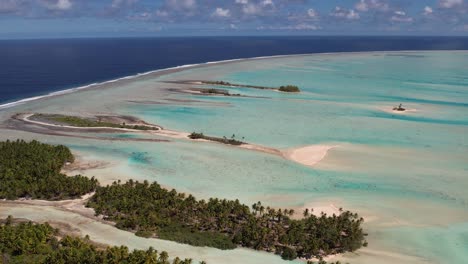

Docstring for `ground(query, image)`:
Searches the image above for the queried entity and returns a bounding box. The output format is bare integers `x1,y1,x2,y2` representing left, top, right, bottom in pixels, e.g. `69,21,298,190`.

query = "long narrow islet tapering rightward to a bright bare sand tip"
10,113,334,167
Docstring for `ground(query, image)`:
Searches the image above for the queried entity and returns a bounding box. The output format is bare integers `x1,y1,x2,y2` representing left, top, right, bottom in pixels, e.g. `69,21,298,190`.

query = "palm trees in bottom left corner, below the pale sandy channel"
0,217,197,264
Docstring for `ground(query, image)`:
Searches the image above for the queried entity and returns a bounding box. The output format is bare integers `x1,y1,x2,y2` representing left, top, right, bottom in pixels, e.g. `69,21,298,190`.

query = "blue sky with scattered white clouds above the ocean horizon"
0,0,468,39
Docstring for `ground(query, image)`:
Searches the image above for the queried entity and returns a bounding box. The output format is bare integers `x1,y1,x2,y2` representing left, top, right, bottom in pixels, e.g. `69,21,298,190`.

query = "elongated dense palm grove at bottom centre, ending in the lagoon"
87,180,365,259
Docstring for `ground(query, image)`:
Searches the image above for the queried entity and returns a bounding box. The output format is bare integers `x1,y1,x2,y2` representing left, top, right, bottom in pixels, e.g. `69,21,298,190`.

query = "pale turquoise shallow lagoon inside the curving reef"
0,51,468,263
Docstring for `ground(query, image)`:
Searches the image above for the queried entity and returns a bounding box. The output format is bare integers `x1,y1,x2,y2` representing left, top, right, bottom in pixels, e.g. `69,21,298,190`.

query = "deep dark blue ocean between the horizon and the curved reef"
0,36,468,103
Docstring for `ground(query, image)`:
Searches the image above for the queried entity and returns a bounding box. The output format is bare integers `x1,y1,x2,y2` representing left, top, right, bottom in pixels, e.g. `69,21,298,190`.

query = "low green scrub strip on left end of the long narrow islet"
30,114,159,130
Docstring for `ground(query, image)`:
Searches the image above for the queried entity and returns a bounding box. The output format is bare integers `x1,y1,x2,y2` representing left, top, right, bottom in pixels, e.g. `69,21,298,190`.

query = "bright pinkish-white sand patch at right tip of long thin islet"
283,145,338,167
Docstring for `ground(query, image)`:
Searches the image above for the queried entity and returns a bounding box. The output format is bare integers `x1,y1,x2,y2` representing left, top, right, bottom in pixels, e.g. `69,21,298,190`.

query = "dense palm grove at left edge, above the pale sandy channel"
0,140,98,200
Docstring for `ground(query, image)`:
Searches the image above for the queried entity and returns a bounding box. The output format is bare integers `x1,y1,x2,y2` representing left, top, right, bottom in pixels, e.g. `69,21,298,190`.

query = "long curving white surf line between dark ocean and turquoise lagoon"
0,50,468,111
